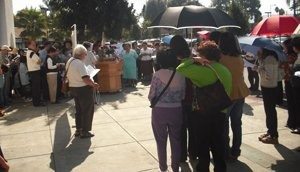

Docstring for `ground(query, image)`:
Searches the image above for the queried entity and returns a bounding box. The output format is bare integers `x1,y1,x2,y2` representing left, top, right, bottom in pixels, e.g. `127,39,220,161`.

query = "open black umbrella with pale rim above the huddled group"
148,5,240,29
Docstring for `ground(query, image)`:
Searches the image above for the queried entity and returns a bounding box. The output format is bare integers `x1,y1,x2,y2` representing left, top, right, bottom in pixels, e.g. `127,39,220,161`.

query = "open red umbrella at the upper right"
250,15,300,37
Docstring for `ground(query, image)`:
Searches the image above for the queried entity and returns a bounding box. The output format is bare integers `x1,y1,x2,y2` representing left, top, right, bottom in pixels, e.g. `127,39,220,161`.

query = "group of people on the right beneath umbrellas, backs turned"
148,32,300,172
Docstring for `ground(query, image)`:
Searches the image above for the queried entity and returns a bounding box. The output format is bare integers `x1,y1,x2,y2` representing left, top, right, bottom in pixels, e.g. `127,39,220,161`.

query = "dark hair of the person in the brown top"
219,32,242,56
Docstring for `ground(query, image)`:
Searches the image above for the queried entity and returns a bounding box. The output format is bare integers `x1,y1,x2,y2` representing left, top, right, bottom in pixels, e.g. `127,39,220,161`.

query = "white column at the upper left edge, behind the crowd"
0,0,16,47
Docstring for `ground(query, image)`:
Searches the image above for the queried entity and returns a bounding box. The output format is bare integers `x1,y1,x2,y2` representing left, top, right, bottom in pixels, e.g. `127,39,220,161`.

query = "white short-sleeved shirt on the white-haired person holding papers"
66,57,89,87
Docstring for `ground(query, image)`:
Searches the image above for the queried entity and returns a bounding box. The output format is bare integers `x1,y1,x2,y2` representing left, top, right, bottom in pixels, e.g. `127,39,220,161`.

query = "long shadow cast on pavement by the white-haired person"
50,113,93,172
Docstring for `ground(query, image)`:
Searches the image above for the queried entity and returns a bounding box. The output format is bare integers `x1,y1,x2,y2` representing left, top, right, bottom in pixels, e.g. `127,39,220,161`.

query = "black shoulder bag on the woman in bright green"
192,65,232,115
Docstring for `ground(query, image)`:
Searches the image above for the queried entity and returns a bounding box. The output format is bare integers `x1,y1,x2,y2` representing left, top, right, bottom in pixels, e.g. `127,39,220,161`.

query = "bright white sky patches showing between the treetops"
12,0,292,15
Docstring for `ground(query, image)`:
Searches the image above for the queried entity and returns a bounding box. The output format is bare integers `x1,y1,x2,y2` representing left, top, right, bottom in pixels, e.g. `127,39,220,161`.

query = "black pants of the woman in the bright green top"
193,112,226,172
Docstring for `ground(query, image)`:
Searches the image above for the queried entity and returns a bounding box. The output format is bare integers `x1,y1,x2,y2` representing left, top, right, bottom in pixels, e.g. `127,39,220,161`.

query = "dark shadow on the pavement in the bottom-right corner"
271,144,300,172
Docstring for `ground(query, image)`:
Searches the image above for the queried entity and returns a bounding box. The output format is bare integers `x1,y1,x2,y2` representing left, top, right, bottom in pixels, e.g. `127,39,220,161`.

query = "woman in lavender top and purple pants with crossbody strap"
148,50,185,172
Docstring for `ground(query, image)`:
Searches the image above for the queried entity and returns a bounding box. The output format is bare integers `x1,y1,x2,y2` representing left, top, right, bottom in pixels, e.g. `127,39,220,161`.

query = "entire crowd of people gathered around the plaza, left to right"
0,31,300,172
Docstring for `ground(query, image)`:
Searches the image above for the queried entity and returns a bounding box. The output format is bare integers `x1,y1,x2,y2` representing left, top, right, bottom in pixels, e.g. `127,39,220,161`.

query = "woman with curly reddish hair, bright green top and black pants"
177,41,232,172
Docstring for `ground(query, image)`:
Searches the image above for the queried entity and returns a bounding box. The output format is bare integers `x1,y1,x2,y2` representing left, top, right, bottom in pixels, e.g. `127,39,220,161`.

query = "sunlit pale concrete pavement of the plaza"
0,82,300,172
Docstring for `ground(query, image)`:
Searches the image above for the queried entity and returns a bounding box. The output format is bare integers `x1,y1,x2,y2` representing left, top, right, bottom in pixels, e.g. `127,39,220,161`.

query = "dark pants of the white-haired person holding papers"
70,86,94,132
